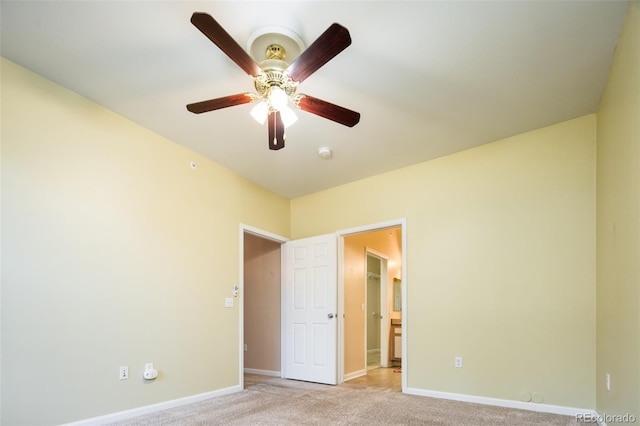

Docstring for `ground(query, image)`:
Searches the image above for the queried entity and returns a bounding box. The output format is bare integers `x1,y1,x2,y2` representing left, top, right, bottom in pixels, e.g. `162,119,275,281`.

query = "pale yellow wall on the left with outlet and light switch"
2,59,289,425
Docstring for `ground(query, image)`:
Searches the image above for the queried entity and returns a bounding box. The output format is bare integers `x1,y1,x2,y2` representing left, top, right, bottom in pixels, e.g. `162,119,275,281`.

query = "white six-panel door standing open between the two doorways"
283,234,338,385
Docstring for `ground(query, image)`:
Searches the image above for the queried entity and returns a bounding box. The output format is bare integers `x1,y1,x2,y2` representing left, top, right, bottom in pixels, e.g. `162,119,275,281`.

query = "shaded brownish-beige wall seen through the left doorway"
244,232,282,374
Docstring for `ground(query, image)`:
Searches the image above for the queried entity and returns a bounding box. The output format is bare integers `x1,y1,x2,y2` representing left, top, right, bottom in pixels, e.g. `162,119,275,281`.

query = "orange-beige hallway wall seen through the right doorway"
343,227,402,375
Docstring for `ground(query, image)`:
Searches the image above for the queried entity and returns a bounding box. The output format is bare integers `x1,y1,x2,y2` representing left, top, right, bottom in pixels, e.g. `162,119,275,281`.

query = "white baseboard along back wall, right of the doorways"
405,388,597,418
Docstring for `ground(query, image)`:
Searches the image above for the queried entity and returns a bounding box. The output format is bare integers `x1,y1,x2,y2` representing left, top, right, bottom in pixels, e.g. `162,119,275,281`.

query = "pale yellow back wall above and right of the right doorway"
291,115,596,408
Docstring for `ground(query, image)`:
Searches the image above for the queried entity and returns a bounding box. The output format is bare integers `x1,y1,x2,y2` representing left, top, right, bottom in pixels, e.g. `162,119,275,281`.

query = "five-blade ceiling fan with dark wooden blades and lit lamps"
187,12,360,150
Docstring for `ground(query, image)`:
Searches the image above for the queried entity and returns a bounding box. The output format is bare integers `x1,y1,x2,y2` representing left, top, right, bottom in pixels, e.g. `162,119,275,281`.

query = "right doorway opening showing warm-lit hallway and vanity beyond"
343,226,402,390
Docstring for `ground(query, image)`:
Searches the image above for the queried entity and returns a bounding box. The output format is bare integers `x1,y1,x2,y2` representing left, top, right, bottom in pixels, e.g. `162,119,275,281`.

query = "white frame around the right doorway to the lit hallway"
337,217,409,392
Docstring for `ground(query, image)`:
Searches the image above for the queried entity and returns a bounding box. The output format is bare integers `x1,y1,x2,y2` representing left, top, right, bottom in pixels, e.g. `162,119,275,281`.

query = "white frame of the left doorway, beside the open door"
237,223,289,389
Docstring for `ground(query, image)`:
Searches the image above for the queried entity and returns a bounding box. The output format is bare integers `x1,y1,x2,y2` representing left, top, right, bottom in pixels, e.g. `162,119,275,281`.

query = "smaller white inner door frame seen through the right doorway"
364,247,389,371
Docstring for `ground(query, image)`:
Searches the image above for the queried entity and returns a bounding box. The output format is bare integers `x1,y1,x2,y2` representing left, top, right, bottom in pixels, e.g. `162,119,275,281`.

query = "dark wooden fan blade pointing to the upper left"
191,12,262,77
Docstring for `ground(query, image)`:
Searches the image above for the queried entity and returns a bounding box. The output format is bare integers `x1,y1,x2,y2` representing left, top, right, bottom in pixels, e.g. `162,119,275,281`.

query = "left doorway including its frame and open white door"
239,230,338,387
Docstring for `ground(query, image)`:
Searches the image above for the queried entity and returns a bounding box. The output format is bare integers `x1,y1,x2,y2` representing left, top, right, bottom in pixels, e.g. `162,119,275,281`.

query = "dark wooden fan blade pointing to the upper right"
287,24,351,83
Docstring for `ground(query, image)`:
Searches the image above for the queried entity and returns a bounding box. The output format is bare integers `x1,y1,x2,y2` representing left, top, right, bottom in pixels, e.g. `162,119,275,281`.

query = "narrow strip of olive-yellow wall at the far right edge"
596,1,640,423
